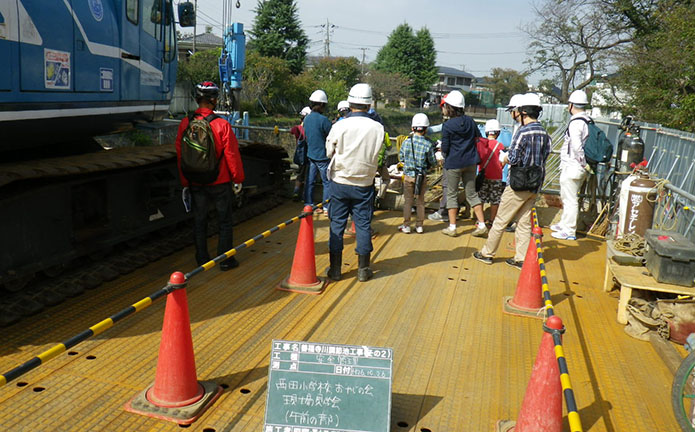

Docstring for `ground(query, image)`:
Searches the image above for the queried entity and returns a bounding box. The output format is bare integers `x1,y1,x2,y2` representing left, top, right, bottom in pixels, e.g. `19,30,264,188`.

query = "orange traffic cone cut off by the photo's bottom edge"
497,315,563,432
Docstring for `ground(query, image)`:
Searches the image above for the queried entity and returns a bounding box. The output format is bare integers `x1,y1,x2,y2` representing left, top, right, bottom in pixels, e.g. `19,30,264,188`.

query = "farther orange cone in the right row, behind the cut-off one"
503,228,543,319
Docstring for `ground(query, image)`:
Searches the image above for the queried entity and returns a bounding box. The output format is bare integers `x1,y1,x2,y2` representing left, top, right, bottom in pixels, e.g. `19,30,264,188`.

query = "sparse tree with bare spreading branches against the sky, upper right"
525,0,632,101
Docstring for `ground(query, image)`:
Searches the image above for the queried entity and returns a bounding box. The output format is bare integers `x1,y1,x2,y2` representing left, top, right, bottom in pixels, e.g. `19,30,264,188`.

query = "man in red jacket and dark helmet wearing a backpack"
176,81,244,271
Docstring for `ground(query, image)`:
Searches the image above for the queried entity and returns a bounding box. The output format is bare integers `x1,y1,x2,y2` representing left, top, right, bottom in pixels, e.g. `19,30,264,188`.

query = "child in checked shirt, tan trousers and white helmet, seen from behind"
398,113,437,234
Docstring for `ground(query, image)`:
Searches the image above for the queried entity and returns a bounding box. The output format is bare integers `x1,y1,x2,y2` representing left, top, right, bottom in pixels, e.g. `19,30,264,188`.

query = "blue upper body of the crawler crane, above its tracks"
0,0,177,151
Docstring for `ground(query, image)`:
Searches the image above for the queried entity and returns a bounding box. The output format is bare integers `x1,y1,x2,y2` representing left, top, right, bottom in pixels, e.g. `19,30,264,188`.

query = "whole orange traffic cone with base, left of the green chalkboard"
125,272,222,425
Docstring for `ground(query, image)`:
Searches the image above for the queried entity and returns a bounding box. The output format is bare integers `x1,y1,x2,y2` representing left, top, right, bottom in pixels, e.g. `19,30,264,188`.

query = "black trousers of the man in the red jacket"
190,183,234,265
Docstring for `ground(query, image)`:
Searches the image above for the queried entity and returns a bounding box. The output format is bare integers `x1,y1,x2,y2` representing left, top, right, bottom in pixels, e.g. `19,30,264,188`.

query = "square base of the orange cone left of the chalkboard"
124,381,223,425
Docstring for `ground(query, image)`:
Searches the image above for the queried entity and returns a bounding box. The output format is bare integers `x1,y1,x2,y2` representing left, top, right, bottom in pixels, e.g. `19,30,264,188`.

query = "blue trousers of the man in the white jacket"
328,182,374,255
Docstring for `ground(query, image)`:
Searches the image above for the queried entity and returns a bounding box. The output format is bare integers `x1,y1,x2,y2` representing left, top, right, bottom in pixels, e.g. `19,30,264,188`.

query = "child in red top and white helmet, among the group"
478,119,504,227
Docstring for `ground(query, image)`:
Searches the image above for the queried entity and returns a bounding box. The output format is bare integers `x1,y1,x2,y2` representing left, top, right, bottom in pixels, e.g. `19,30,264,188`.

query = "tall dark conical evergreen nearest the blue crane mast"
249,0,309,74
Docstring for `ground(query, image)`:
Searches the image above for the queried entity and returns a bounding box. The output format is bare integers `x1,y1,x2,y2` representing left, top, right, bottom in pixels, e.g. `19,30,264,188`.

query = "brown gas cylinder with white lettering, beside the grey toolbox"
616,172,656,238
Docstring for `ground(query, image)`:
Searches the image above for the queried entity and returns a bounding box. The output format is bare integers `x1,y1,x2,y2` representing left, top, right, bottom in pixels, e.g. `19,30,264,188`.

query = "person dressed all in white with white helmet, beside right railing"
550,90,591,240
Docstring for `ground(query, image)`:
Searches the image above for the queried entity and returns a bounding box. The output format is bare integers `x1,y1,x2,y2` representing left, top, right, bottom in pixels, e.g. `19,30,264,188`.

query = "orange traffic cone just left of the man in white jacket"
278,205,326,294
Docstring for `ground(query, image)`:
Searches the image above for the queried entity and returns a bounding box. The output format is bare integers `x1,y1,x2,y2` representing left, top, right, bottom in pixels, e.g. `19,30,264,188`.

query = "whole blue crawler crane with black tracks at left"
0,0,287,320
